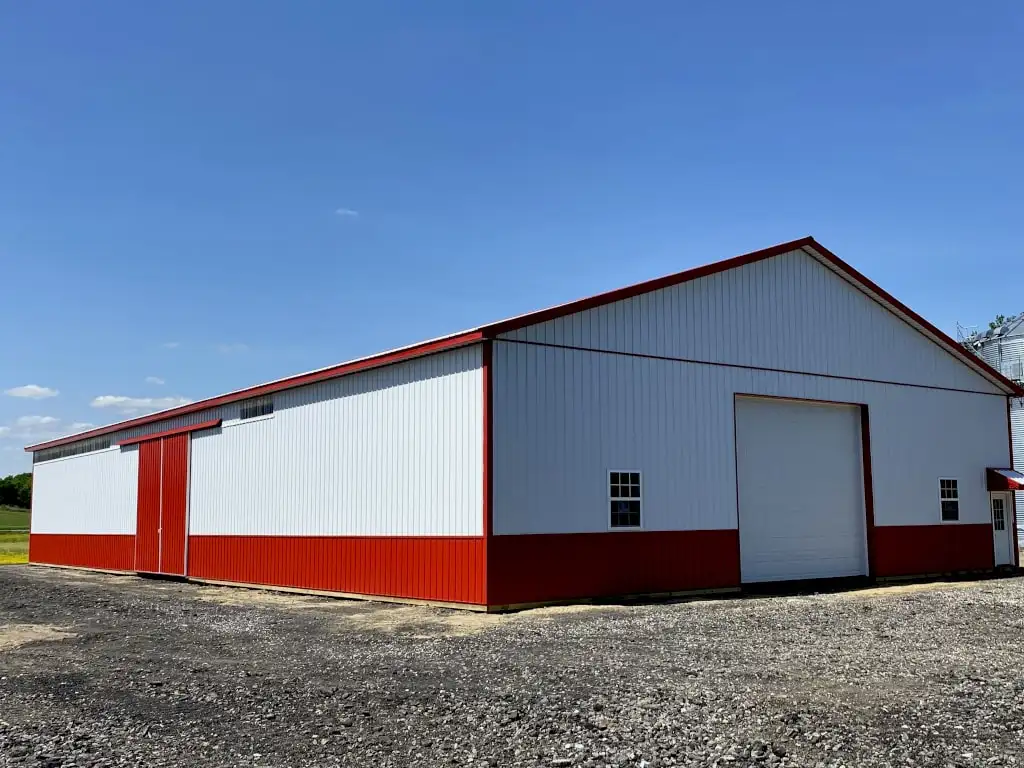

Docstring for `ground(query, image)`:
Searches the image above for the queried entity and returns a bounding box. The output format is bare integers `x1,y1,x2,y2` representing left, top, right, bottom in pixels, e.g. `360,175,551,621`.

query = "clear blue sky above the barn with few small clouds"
0,0,1024,475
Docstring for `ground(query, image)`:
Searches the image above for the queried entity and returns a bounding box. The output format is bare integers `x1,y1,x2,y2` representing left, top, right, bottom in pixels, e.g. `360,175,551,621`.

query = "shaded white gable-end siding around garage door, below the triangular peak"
492,342,1009,534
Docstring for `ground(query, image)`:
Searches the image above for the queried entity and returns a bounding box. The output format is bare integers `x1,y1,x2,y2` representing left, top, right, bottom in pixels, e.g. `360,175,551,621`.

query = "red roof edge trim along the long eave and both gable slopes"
26,237,1024,451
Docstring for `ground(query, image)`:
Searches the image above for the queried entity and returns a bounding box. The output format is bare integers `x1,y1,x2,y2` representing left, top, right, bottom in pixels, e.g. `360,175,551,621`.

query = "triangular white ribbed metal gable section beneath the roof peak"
499,251,999,392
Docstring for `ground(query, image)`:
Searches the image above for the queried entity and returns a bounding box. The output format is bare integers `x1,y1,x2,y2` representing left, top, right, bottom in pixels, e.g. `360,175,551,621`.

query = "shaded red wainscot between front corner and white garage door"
487,530,739,606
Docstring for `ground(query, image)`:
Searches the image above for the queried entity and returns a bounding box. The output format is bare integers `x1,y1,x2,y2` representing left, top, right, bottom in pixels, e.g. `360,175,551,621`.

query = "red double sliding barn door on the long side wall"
135,433,189,575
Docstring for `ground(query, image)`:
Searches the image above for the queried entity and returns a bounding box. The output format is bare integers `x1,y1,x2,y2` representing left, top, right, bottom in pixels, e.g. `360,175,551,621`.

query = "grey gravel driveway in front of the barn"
0,566,1024,768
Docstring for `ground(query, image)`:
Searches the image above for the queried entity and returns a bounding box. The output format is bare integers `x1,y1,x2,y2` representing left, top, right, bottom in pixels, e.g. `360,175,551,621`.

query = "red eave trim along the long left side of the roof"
25,331,483,453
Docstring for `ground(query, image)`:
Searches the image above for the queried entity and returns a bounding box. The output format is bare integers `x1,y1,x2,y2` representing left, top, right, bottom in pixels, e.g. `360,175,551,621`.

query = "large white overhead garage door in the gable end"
736,397,867,583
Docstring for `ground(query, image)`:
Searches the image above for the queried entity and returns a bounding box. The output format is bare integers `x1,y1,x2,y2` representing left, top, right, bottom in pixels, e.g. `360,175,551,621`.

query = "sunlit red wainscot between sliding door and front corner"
188,536,486,605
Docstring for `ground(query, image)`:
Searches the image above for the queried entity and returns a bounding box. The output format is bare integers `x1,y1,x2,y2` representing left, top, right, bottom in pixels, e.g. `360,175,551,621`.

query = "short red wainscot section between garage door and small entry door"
874,523,995,577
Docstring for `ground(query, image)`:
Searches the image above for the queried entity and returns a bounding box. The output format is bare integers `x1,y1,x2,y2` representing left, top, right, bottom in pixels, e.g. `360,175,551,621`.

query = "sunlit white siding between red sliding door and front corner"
189,346,483,536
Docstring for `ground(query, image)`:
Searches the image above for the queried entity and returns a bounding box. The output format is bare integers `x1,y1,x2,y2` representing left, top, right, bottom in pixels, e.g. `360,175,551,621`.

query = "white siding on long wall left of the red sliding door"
32,446,138,534
